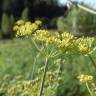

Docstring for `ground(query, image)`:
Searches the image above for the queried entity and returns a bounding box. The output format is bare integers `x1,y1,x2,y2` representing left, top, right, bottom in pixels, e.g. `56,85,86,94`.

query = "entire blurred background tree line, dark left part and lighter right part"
0,0,96,38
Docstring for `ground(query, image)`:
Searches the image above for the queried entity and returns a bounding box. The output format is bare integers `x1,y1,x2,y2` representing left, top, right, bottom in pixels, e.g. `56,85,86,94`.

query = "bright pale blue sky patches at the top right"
58,0,96,10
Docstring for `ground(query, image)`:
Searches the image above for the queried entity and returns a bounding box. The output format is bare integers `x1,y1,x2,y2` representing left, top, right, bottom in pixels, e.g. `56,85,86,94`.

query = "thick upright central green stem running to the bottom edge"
38,58,48,96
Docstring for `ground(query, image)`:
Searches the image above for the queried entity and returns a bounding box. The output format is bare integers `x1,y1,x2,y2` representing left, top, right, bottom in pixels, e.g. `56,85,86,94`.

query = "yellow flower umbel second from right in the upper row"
58,32,77,53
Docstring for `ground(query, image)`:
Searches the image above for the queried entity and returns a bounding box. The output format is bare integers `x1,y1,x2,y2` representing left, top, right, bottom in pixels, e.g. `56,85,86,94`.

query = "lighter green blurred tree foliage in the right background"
57,7,96,35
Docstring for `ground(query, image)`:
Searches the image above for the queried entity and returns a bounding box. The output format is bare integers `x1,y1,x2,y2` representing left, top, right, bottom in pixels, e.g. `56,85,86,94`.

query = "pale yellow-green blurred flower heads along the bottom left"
0,70,59,96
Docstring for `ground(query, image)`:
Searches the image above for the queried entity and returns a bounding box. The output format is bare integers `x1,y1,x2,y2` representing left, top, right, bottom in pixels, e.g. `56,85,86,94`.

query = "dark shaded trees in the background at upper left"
0,0,67,38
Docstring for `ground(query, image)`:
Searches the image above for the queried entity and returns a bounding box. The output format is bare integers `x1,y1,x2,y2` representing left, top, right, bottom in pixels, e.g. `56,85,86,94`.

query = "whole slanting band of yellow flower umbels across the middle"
13,20,96,55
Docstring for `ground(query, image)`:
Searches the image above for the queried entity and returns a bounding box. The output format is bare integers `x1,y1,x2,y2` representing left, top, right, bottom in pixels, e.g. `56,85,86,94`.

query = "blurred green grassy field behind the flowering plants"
0,39,96,96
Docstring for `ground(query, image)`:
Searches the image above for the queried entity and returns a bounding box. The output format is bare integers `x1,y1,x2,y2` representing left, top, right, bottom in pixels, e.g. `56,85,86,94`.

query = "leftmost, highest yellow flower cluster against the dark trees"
13,20,42,37
